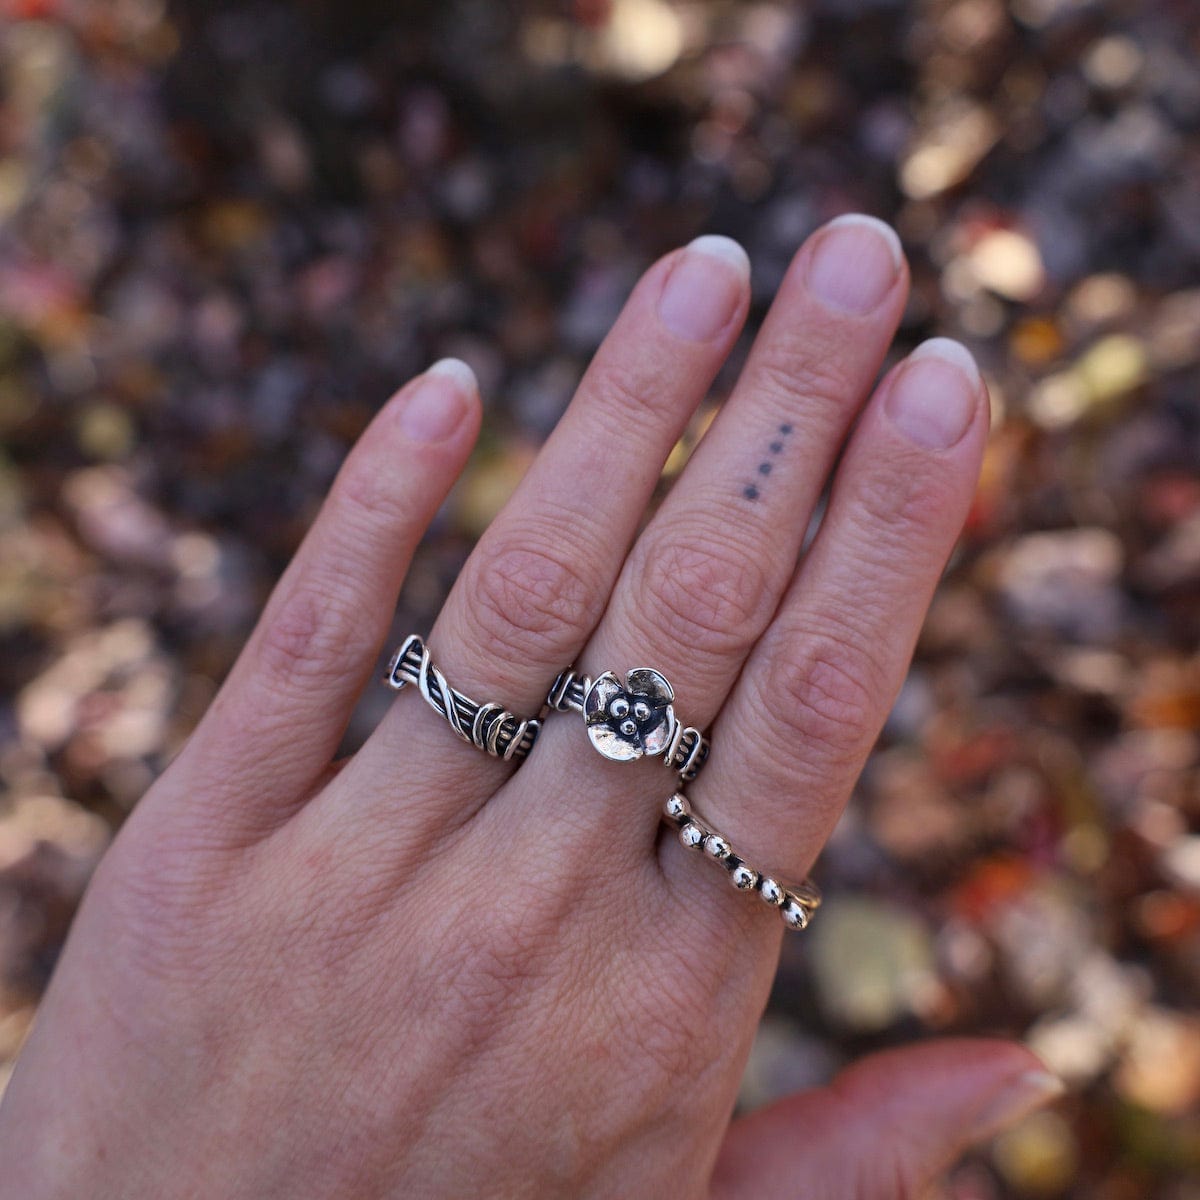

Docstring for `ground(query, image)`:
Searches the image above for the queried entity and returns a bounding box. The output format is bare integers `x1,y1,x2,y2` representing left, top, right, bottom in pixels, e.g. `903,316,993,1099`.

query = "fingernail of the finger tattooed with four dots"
806,212,904,313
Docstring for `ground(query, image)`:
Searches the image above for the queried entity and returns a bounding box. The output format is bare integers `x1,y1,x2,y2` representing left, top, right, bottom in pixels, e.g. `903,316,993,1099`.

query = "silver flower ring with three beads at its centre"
546,667,709,781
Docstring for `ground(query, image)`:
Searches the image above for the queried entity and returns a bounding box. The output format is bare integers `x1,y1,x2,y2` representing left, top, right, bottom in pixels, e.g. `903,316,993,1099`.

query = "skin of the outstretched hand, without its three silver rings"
0,218,1054,1200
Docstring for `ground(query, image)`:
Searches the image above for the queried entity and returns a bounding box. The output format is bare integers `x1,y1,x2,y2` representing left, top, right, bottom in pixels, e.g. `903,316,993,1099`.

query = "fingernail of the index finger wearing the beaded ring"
883,337,983,450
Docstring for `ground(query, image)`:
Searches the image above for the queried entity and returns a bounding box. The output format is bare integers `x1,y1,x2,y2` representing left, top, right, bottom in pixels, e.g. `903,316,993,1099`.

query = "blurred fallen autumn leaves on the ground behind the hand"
0,0,1200,1200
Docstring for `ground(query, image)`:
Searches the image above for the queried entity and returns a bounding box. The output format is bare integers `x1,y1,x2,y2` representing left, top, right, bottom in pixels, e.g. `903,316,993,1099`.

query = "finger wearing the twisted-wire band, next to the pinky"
319,236,750,840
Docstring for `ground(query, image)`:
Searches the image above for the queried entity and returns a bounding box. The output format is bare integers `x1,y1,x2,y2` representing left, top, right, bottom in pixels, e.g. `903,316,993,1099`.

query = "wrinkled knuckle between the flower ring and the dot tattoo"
636,529,770,658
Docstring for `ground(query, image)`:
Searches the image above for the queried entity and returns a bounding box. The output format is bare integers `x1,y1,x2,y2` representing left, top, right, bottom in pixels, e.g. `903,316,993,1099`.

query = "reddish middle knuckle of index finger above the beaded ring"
762,629,883,764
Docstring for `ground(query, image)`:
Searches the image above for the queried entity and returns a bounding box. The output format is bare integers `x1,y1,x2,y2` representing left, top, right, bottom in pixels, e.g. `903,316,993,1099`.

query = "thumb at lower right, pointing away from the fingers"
713,1038,1063,1200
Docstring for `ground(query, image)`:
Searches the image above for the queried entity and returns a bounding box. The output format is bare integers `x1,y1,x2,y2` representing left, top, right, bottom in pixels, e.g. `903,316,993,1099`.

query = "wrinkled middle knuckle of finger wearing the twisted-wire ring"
464,526,604,661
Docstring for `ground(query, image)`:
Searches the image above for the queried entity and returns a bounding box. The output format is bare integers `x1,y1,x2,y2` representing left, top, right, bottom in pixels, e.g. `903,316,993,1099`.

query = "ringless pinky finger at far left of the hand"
165,359,480,839
